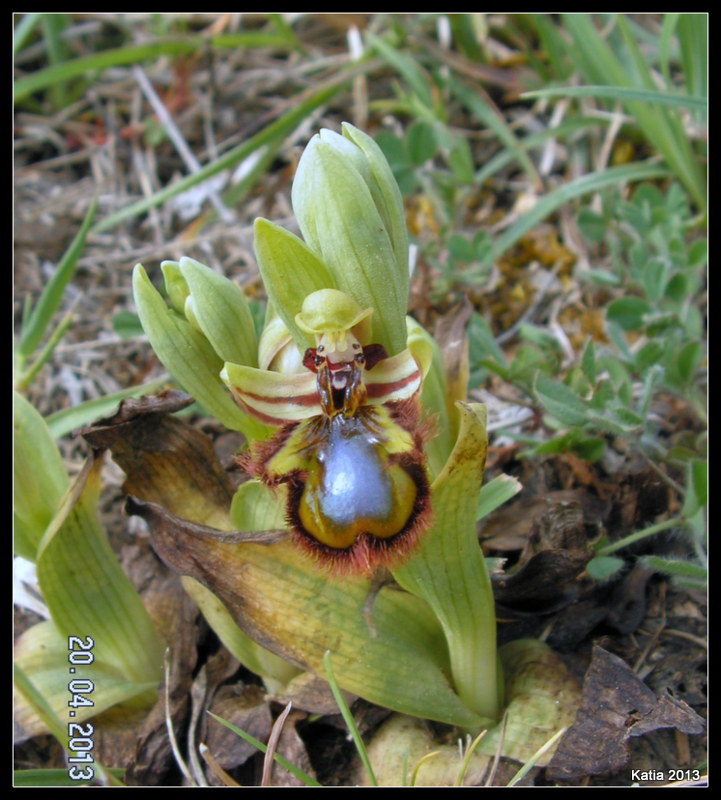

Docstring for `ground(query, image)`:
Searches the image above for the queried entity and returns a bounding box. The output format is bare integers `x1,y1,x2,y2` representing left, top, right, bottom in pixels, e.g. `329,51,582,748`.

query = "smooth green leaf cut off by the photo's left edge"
13,392,68,561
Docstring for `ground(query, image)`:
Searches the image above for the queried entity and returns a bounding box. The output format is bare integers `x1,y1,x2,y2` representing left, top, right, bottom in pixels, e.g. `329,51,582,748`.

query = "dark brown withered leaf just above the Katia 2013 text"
546,646,704,782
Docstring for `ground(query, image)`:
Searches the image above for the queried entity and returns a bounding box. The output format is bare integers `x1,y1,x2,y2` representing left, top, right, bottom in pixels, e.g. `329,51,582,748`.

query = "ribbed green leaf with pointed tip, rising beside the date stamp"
37,459,163,685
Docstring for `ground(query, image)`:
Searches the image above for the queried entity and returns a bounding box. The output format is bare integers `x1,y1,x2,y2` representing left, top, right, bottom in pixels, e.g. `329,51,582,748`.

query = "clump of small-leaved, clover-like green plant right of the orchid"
471,178,707,585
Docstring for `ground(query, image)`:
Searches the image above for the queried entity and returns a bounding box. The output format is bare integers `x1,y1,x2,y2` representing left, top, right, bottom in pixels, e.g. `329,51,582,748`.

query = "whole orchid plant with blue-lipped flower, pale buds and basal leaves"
131,120,580,776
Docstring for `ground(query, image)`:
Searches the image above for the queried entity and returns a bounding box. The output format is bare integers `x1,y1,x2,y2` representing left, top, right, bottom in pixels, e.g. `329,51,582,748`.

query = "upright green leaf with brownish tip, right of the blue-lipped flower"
393,404,500,720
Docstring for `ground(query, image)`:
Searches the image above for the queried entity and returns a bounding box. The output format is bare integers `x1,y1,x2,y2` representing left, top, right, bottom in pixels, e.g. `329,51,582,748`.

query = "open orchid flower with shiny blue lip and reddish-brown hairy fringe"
222,289,430,573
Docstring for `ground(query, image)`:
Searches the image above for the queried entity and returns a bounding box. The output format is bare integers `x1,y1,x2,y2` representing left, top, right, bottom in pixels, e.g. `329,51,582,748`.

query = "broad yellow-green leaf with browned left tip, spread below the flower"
130,503,482,727
